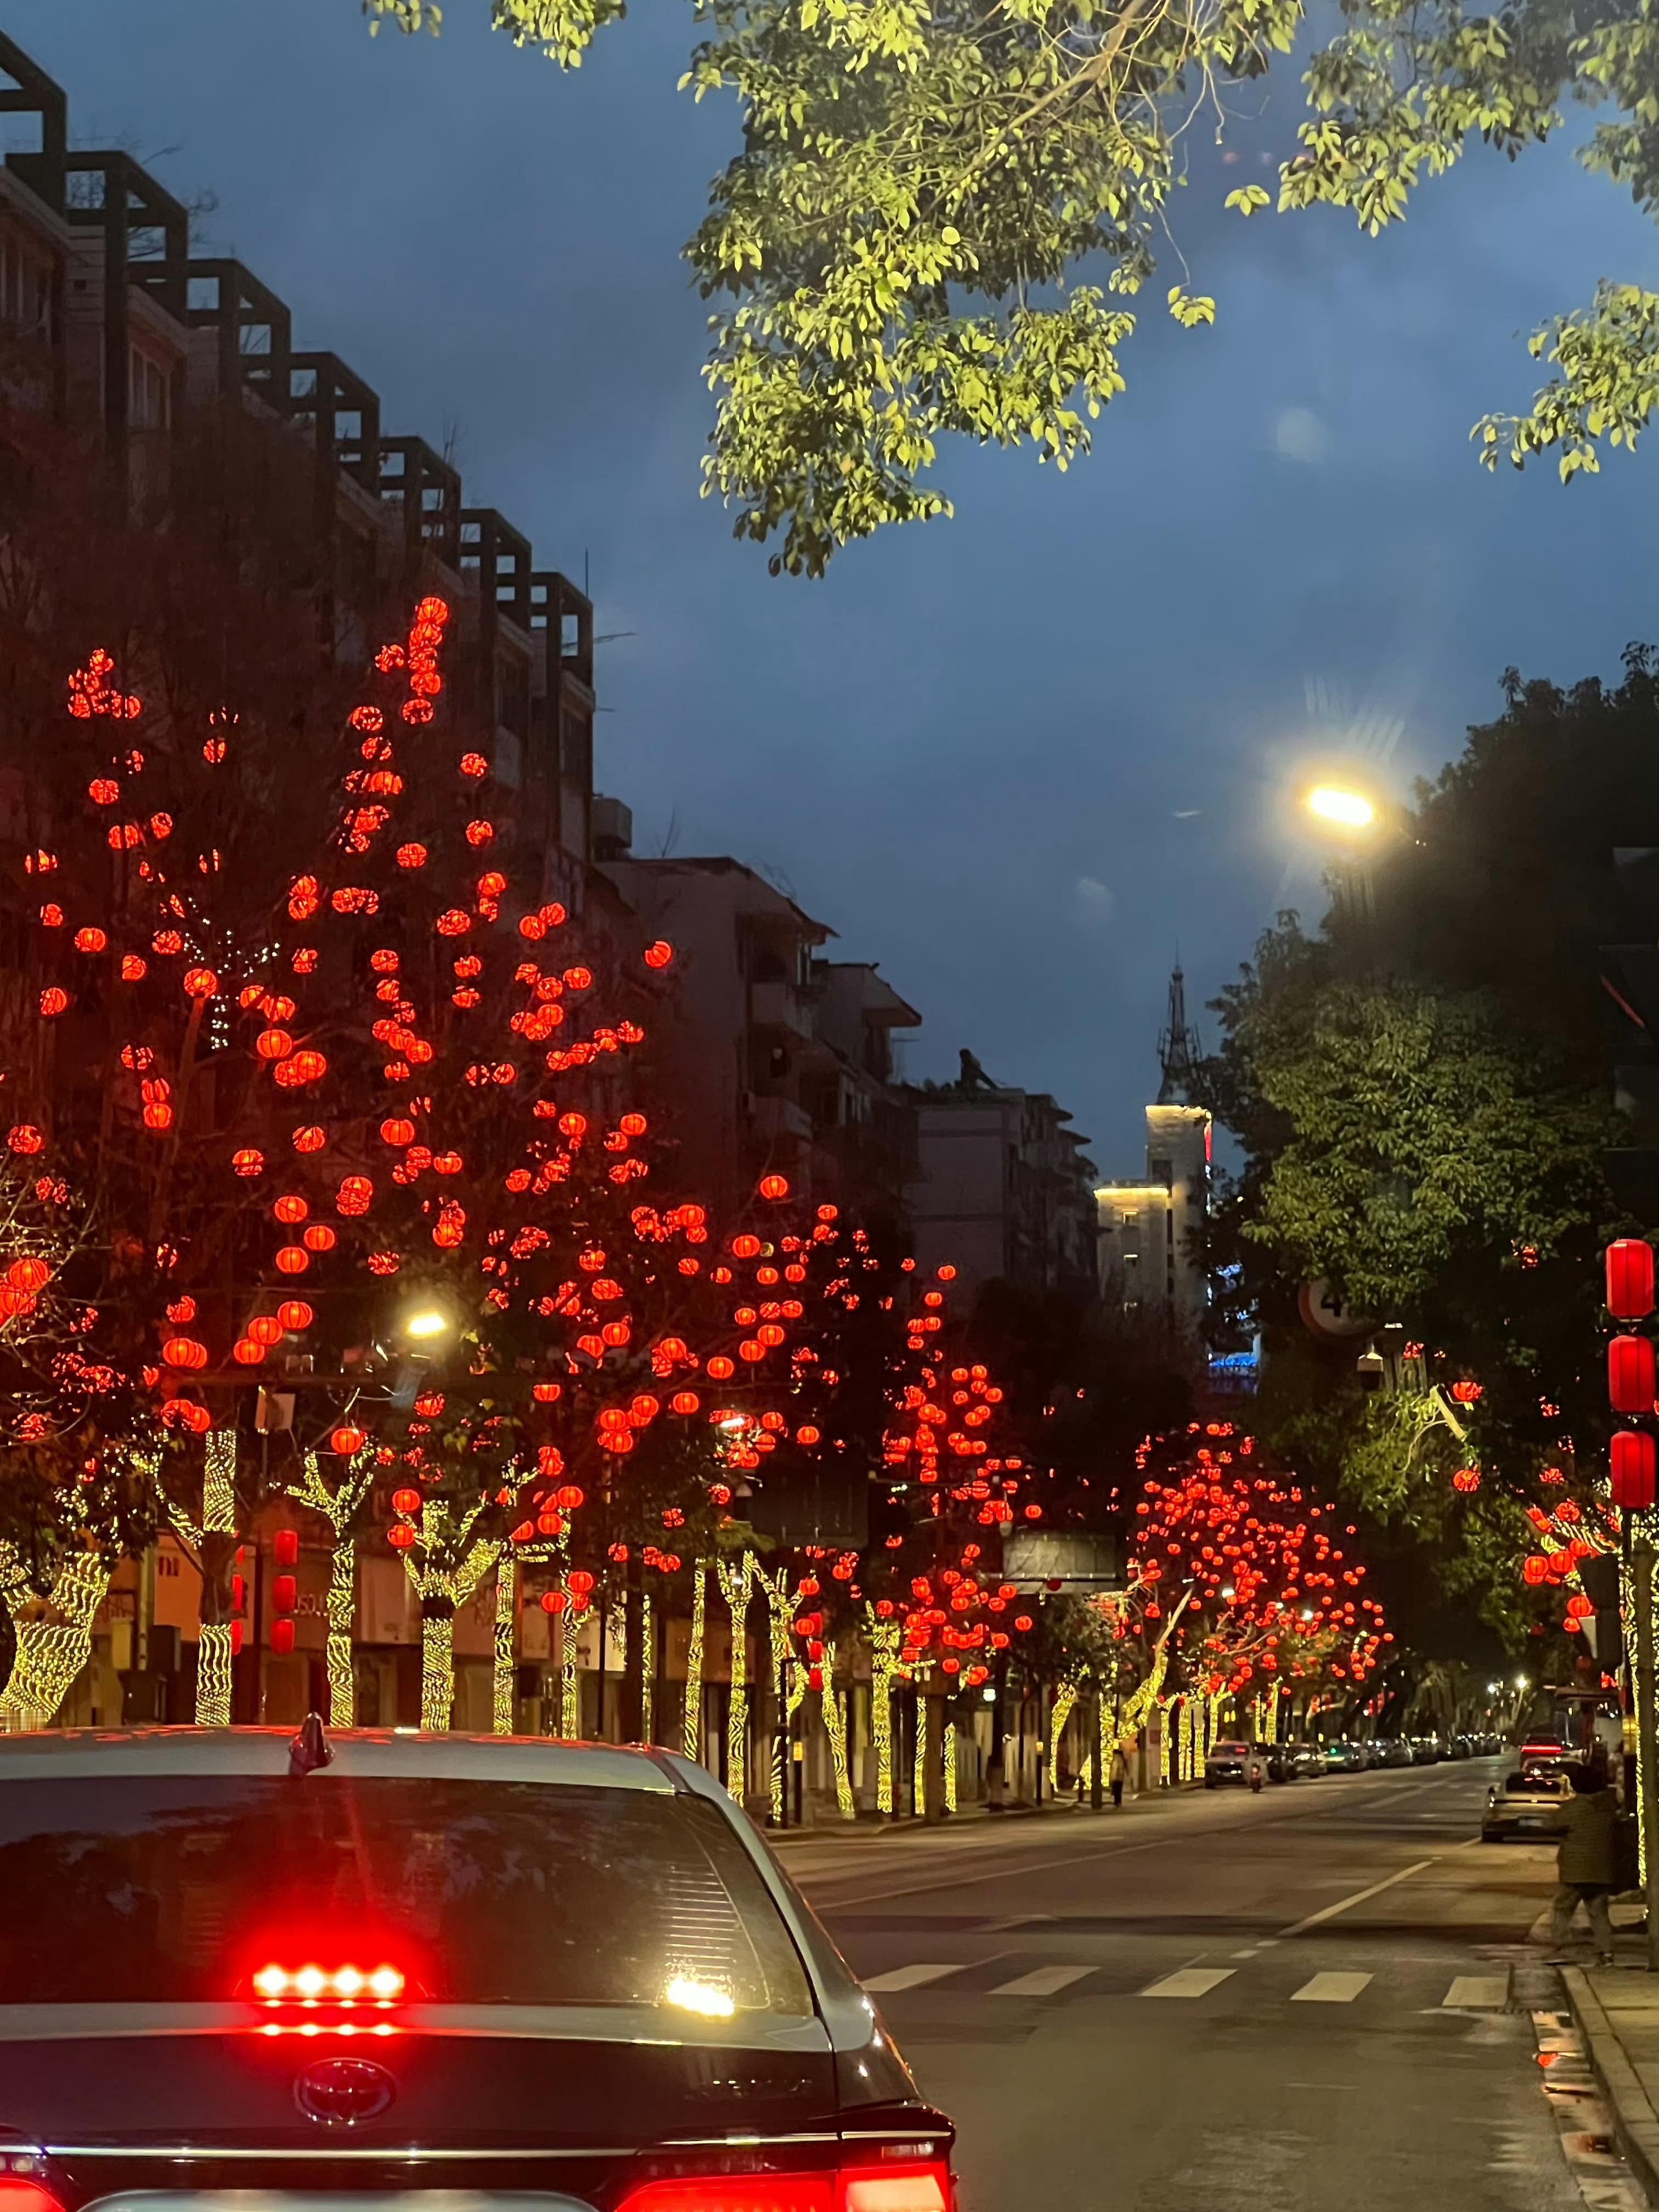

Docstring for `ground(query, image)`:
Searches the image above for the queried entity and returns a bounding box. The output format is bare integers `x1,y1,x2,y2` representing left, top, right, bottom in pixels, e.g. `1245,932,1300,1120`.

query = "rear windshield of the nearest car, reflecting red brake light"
0,1774,812,2017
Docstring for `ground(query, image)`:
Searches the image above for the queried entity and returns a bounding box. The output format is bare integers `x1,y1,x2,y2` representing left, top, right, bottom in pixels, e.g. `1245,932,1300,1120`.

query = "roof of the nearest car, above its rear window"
0,1728,681,1796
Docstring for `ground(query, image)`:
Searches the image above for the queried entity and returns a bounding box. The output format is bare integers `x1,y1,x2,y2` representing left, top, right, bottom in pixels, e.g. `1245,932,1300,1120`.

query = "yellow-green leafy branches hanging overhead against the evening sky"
363,0,1659,575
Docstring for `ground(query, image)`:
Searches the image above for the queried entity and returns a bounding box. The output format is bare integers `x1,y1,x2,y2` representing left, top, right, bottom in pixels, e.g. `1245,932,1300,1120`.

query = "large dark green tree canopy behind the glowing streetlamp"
1207,648,1659,1635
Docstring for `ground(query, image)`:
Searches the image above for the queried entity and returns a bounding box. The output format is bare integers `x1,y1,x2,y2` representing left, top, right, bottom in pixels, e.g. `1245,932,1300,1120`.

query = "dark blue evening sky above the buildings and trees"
16,0,1659,1172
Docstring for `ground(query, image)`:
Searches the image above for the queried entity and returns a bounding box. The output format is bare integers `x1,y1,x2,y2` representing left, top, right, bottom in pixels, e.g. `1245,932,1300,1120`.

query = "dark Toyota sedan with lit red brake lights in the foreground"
0,1719,953,2212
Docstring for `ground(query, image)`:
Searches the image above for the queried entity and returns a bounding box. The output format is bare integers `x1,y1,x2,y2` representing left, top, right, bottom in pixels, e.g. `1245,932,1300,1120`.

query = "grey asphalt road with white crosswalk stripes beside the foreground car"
785,1760,1637,2212
